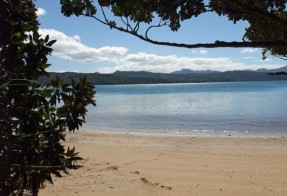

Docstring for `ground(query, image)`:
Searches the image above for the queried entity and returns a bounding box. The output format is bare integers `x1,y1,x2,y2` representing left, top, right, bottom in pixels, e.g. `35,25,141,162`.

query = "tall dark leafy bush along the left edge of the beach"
0,0,95,195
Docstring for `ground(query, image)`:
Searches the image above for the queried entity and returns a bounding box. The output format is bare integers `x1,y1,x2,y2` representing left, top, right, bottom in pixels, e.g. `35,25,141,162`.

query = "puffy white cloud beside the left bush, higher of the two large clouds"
40,29,128,63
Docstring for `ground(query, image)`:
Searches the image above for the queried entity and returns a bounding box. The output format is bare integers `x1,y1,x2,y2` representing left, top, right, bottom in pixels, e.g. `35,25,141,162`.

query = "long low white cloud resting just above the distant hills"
97,53,266,73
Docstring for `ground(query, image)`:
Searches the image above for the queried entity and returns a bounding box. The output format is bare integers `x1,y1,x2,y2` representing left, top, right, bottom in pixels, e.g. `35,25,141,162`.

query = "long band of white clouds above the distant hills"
40,29,280,73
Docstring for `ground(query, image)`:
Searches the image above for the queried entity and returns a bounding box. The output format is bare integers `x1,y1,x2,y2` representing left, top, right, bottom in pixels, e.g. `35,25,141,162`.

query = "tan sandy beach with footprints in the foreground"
39,131,287,196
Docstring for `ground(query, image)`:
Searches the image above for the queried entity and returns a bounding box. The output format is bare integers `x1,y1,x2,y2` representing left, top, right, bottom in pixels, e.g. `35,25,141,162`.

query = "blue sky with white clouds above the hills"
36,0,287,73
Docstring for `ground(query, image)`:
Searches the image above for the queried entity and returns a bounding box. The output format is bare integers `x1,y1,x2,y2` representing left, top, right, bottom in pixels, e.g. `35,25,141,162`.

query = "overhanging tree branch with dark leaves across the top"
61,0,287,59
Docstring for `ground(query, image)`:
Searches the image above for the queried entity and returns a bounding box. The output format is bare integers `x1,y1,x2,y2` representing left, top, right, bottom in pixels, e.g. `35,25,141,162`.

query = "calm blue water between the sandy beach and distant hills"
85,81,287,136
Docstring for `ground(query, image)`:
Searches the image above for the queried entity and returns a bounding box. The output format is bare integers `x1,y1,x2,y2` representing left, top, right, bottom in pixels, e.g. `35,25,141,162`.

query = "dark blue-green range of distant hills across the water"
39,66,287,85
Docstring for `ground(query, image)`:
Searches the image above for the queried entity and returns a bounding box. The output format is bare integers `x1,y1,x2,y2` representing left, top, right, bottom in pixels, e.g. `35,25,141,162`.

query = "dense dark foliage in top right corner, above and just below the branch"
210,0,287,59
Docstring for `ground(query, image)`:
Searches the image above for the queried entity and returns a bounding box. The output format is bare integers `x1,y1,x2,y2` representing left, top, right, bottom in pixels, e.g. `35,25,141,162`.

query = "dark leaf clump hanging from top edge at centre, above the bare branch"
98,0,206,31
